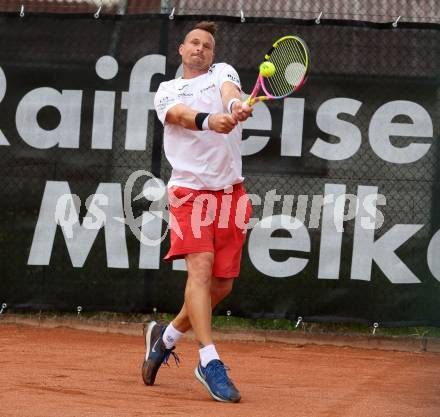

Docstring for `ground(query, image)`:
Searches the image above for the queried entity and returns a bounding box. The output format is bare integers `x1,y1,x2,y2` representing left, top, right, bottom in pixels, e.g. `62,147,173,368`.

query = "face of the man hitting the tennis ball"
179,29,214,71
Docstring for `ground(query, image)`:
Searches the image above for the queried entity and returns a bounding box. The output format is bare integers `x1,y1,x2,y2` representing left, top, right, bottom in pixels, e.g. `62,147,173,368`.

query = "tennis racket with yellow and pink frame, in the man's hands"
246,36,310,106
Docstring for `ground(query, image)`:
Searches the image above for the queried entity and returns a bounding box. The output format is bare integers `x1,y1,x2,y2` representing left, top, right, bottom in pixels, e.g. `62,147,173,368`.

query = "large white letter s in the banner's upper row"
310,98,362,161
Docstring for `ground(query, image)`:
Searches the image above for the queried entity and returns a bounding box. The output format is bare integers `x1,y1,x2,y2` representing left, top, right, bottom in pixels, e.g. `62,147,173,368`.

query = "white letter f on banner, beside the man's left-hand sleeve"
121,55,166,151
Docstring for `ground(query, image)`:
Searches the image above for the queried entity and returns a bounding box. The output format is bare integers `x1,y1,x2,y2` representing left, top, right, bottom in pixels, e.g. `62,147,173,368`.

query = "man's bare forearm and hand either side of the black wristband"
165,103,237,133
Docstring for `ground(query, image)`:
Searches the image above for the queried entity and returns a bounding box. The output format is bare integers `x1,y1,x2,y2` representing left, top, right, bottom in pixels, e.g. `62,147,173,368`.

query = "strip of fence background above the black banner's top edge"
0,0,440,23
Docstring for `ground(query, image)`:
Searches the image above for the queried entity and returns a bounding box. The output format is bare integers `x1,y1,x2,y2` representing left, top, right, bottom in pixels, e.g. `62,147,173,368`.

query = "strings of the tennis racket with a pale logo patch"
264,38,307,97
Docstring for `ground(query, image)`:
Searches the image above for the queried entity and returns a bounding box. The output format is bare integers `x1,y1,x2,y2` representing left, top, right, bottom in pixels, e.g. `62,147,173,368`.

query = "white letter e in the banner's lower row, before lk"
248,214,311,278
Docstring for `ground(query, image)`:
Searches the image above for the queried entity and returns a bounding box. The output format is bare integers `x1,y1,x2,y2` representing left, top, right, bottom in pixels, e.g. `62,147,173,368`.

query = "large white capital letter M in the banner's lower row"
28,181,128,268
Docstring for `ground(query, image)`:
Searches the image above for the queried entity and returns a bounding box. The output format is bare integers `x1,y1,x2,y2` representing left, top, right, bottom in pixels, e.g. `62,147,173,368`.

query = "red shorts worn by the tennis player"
164,183,252,278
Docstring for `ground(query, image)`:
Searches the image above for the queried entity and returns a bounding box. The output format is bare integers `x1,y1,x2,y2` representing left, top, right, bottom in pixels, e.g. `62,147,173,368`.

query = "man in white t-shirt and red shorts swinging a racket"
142,22,252,402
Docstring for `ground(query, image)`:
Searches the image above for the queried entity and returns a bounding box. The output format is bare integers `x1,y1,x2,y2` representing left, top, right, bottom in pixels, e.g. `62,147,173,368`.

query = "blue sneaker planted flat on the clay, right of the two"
194,359,241,403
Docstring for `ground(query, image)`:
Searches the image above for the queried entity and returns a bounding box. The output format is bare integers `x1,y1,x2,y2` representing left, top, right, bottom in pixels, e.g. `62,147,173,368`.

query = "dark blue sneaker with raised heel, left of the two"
142,321,180,385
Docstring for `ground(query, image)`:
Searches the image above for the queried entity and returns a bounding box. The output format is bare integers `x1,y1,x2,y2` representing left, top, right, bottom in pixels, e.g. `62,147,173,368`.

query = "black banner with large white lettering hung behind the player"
0,14,440,326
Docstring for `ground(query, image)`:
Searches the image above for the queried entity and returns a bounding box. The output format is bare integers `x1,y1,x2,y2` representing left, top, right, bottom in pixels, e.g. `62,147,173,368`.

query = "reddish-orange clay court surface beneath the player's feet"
0,324,440,417
